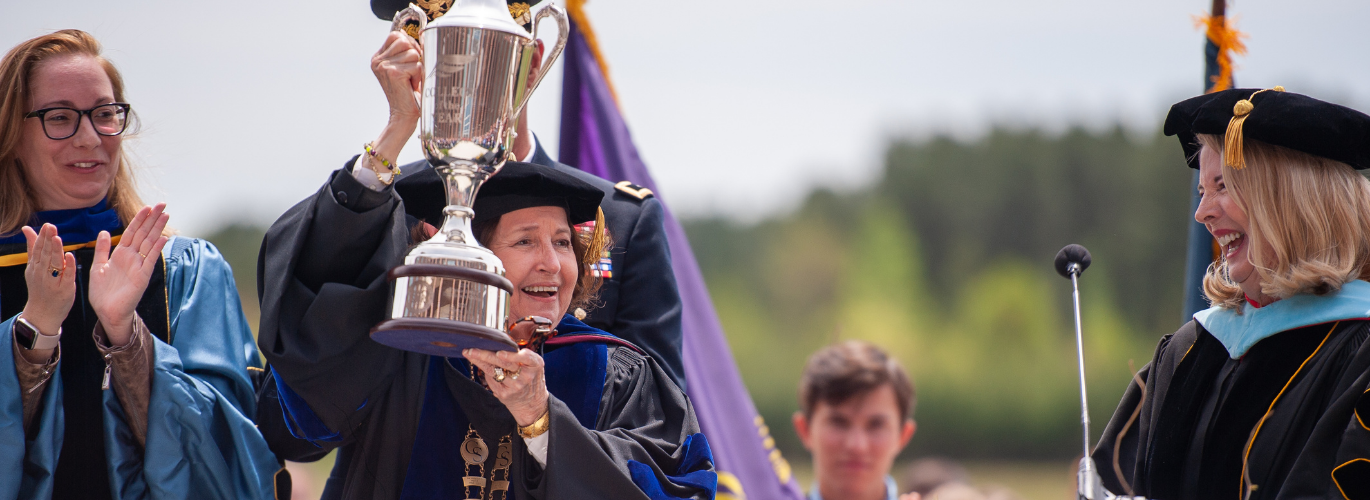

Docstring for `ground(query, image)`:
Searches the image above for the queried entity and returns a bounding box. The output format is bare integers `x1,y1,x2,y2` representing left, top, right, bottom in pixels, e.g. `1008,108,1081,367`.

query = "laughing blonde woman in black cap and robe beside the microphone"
1092,86,1370,500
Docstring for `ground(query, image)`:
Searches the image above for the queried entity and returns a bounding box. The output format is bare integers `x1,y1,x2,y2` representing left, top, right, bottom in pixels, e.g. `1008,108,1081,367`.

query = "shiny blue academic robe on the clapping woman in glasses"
0,237,284,499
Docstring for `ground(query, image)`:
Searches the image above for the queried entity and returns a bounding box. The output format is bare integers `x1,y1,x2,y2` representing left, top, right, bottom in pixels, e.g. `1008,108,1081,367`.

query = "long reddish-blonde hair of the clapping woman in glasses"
0,30,146,236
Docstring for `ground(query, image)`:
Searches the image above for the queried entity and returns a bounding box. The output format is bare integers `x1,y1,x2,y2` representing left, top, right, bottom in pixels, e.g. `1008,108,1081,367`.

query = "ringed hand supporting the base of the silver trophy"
462,349,551,426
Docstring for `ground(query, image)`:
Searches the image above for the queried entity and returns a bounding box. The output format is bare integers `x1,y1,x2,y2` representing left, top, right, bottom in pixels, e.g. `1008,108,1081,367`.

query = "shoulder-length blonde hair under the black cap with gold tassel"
1197,134,1370,310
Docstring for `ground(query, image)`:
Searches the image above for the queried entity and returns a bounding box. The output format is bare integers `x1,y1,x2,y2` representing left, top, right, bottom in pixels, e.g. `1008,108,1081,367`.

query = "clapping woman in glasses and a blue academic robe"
0,30,282,499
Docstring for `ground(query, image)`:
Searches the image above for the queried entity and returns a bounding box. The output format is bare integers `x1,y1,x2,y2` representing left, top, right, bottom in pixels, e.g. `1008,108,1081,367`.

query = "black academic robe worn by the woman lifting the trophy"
250,162,712,499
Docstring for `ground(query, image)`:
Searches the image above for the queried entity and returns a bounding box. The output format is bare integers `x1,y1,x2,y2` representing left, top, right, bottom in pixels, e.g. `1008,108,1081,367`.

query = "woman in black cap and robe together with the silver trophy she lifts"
259,1,717,499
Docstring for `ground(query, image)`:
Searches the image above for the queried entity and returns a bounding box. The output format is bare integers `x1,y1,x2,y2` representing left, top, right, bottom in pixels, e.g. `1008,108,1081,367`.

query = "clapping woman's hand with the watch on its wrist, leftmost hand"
23,223,77,363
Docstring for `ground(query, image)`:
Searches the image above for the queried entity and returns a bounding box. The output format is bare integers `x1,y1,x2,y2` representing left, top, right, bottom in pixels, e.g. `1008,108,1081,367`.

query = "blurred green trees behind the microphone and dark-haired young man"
686,123,1189,459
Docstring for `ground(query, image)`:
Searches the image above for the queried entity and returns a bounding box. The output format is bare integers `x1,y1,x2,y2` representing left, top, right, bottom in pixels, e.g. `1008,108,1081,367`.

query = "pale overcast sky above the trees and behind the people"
0,0,1370,236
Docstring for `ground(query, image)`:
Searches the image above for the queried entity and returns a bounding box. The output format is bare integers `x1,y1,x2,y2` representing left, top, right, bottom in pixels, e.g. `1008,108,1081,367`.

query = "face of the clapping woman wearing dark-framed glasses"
19,55,122,210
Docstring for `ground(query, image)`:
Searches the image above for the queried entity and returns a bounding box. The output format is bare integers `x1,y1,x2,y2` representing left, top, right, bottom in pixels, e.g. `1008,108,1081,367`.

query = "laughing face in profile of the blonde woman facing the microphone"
1195,148,1263,301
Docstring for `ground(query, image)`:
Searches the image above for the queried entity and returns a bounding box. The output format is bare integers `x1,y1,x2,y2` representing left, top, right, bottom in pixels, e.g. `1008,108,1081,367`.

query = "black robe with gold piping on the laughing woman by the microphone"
1092,321,1370,500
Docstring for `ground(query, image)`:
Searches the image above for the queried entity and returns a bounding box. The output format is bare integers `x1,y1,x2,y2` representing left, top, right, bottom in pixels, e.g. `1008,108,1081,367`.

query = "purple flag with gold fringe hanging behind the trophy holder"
560,12,803,500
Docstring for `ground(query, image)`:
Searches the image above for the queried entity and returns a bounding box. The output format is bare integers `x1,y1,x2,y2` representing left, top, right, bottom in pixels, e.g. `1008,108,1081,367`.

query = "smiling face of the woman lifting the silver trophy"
486,207,577,331
